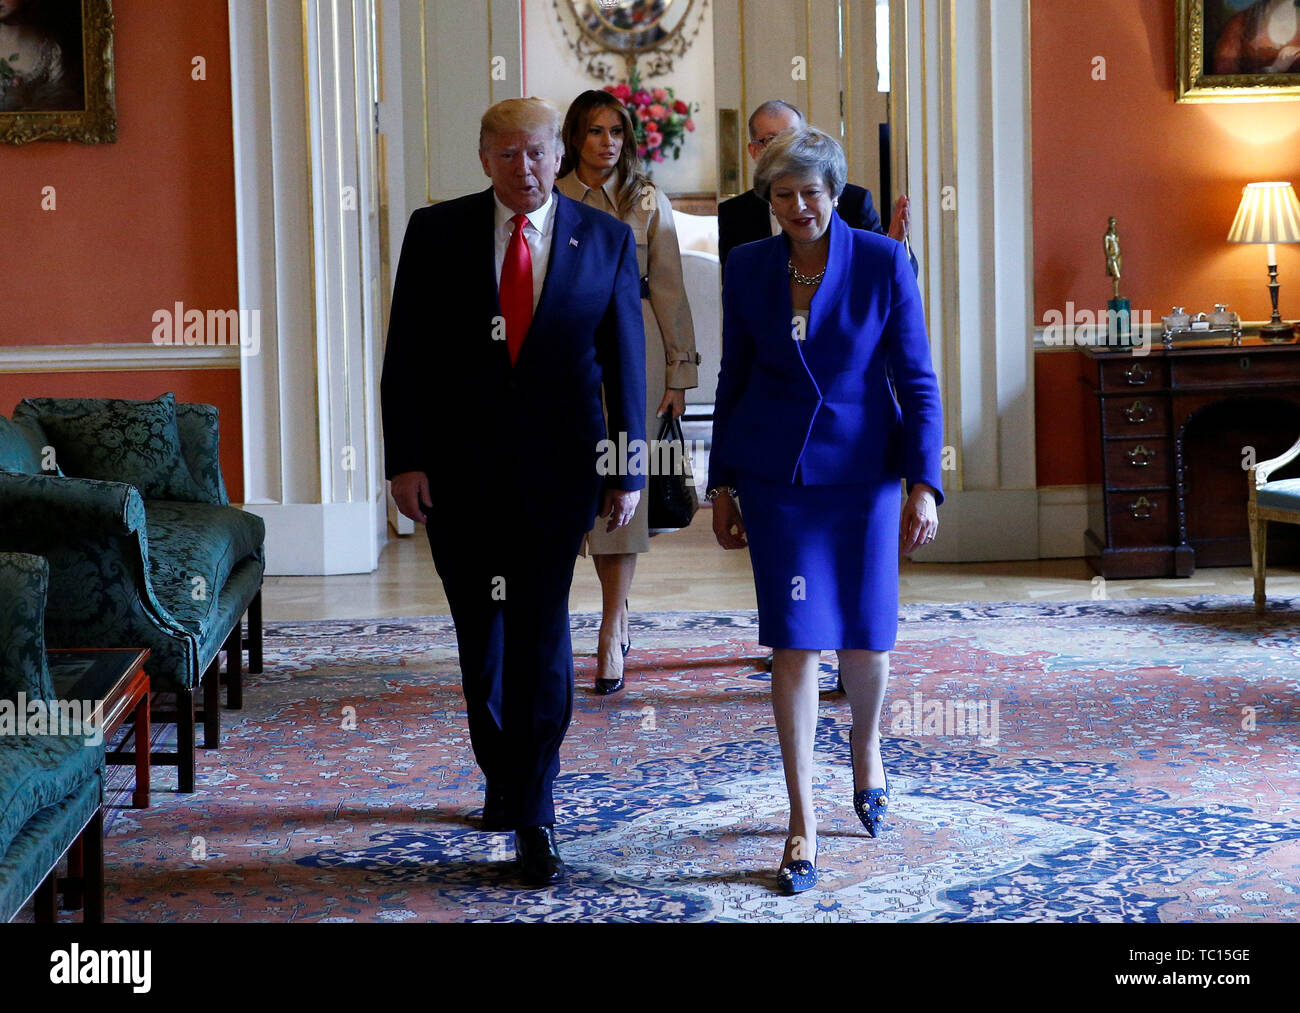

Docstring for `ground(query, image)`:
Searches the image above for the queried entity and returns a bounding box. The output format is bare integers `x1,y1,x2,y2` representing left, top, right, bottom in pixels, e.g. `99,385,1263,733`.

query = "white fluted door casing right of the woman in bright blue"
891,0,1039,562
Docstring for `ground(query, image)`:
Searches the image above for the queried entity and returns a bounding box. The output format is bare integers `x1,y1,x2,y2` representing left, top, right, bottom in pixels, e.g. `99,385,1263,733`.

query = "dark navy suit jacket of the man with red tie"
380,187,646,527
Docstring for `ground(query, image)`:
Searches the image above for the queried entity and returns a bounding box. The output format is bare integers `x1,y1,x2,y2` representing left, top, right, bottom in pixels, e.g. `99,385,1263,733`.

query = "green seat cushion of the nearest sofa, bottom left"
0,735,104,854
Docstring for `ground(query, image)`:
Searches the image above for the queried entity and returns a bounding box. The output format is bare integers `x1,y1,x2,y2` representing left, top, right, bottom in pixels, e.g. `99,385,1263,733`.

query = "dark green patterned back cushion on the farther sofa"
43,394,205,502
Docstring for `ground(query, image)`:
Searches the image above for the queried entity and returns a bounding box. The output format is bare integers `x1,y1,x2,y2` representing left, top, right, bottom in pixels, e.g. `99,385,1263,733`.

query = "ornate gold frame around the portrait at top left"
0,0,117,144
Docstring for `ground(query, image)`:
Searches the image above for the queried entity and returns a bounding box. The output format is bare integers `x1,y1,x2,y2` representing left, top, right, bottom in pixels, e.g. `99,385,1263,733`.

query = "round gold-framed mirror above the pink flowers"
551,0,709,83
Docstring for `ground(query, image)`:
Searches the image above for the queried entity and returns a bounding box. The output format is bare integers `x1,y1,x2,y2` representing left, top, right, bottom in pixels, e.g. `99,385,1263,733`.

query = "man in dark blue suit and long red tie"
381,99,646,884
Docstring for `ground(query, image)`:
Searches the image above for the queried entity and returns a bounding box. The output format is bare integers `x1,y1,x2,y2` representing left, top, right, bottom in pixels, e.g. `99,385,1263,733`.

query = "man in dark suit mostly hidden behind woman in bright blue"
718,99,918,277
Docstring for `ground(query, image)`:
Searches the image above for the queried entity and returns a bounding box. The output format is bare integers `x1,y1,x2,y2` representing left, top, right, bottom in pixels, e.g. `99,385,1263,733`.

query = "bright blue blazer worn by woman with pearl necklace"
709,215,944,502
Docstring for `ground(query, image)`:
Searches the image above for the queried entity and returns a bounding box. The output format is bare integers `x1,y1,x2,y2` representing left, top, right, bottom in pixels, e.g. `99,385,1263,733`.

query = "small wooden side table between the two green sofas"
46,648,150,809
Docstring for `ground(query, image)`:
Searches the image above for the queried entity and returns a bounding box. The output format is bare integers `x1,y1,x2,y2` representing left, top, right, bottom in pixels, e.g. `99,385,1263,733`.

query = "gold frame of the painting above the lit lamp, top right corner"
1175,0,1300,103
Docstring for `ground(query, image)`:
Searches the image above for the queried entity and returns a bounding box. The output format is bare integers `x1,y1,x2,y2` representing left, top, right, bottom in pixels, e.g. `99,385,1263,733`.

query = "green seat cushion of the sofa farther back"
144,499,267,637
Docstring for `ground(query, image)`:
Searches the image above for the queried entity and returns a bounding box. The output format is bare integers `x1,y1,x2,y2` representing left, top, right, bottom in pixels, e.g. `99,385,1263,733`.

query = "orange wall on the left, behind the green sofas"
0,0,243,502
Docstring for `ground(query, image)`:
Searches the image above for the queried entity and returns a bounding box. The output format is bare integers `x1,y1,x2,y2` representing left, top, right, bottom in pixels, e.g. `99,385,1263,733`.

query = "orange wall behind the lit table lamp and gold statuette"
1030,0,1300,485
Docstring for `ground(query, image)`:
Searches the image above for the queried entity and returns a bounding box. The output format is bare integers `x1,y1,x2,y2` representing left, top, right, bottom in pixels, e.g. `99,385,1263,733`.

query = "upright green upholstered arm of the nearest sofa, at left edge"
0,553,55,700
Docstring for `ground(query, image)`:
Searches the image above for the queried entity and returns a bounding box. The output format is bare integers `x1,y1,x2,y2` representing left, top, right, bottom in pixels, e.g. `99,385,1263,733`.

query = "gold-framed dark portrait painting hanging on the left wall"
0,0,117,144
